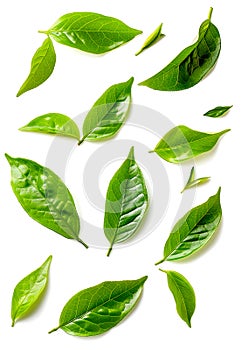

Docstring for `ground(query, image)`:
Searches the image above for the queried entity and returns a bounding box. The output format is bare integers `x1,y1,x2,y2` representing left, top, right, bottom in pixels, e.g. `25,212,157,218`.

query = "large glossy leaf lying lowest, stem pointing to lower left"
49,276,147,337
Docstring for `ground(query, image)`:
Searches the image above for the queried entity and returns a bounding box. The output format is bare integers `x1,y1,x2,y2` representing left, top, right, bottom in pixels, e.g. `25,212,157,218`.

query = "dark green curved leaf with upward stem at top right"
139,8,221,91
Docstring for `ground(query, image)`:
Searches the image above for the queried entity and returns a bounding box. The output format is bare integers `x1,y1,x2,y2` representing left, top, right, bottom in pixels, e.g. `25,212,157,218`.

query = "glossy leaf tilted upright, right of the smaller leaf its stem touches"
79,78,134,144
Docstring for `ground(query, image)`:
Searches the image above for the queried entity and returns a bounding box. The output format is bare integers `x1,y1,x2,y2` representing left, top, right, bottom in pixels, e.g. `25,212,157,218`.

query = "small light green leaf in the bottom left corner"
11,256,52,327
